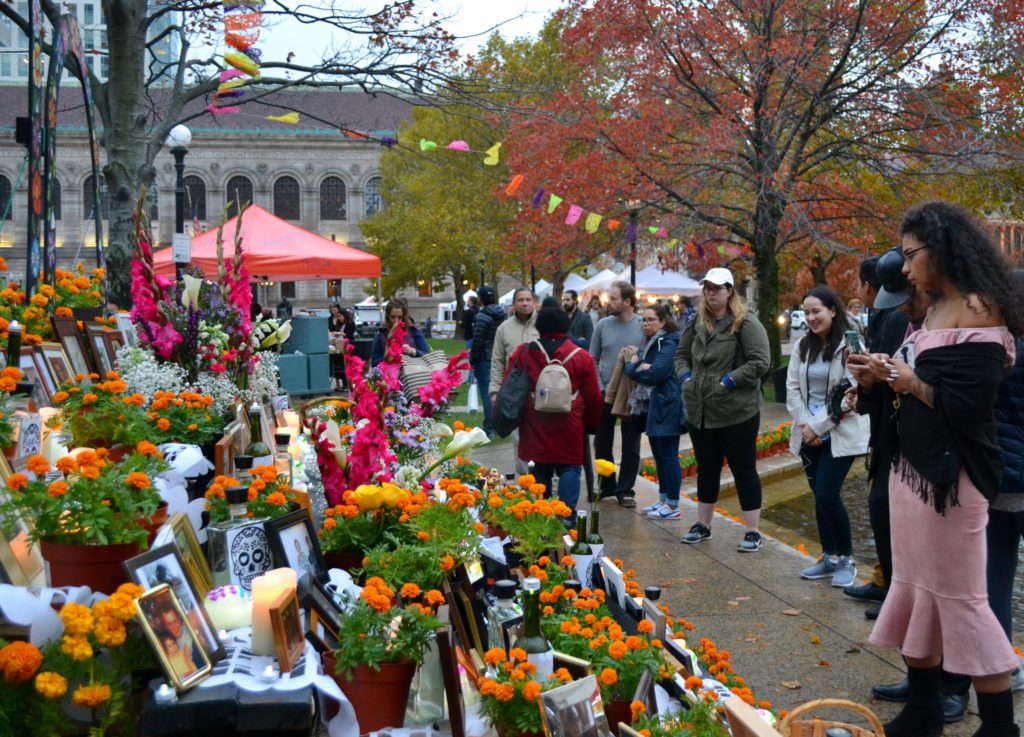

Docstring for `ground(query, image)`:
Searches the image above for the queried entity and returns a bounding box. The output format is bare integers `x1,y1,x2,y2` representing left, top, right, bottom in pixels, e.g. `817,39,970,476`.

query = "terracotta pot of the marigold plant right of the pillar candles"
323,652,416,734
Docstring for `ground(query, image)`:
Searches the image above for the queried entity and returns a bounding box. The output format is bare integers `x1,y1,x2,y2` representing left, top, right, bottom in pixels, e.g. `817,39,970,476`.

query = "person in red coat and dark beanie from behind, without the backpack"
505,302,602,519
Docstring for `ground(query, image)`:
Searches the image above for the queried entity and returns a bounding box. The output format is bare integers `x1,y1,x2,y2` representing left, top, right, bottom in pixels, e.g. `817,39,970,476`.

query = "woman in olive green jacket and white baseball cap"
675,268,771,553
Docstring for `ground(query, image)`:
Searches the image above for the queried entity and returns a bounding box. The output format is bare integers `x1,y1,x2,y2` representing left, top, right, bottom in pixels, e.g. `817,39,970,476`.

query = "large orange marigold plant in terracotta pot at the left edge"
0,442,168,592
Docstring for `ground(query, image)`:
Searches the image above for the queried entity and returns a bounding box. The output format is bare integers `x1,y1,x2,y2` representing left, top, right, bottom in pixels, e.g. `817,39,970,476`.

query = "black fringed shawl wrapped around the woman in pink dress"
892,341,1007,514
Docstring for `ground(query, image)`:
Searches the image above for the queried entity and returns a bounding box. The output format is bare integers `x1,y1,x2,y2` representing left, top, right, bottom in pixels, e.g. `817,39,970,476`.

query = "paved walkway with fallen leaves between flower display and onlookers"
473,404,1024,737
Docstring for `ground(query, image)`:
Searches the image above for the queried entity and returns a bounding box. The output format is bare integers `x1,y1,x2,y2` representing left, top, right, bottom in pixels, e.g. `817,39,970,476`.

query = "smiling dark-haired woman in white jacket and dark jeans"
785,287,870,589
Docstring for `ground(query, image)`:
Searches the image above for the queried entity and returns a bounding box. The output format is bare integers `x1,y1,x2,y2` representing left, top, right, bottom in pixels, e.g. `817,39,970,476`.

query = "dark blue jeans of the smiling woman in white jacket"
800,440,853,556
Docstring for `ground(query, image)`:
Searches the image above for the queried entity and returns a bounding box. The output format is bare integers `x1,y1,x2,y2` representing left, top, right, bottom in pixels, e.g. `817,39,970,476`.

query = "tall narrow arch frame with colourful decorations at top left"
25,0,104,296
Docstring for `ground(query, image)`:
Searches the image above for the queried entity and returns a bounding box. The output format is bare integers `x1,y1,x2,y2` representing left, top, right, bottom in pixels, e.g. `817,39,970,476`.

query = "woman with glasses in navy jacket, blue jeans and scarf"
626,303,684,519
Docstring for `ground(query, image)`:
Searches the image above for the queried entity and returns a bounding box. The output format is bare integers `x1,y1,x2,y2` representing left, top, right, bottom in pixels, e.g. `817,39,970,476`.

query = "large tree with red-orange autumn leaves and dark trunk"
499,0,1000,364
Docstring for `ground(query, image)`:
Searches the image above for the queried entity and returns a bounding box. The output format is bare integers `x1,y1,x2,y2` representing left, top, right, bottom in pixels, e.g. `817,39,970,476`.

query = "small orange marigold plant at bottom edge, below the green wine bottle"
476,648,572,737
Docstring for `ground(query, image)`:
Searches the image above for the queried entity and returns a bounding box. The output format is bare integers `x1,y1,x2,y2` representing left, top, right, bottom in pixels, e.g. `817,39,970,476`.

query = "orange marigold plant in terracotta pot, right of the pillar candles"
324,577,444,734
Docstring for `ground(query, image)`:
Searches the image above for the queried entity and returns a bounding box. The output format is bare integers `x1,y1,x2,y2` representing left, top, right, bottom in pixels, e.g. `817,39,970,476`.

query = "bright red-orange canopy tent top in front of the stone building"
153,205,381,281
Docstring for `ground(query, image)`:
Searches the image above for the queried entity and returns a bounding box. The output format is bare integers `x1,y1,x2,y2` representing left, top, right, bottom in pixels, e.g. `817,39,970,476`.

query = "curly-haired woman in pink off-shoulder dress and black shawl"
848,202,1022,737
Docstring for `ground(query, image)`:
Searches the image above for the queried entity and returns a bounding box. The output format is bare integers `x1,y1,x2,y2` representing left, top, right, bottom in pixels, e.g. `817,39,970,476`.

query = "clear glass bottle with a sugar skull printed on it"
207,486,272,592
